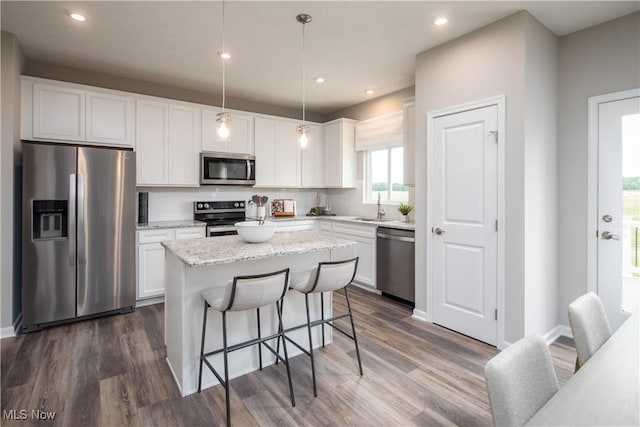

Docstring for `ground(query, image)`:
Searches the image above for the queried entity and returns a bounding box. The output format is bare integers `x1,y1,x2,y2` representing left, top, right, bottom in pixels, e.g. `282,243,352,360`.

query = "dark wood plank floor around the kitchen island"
0,288,575,426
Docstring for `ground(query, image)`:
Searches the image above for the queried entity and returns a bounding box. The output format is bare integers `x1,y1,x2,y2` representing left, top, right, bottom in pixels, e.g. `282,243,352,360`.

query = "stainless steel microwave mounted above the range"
200,151,256,185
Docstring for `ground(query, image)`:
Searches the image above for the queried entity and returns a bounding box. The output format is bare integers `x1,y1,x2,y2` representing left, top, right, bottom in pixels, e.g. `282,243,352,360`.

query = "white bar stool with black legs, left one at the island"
198,268,296,426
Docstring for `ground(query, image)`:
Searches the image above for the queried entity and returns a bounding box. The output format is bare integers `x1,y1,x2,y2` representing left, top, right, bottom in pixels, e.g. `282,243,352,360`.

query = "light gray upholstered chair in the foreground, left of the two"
484,334,559,427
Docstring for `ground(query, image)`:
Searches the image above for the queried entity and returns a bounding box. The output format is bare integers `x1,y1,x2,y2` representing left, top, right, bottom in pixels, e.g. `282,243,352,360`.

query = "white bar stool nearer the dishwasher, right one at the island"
276,257,362,397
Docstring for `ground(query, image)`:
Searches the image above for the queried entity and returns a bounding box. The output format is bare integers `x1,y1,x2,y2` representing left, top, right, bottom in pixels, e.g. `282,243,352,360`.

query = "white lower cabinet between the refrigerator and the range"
136,227,205,300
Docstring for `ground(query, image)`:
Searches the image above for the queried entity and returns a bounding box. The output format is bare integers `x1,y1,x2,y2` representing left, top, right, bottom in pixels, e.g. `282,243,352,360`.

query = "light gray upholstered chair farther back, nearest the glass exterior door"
568,292,611,371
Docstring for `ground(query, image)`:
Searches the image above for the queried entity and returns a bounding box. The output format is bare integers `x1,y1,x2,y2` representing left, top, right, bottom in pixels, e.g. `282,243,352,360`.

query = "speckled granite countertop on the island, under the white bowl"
162,231,357,267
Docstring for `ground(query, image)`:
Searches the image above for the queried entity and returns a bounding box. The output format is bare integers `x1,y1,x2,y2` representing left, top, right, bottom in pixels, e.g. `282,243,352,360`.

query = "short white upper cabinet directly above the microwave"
202,108,255,154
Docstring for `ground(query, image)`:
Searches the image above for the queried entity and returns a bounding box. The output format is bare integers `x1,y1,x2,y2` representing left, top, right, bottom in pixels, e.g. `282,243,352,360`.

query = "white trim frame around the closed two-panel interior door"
425,95,507,350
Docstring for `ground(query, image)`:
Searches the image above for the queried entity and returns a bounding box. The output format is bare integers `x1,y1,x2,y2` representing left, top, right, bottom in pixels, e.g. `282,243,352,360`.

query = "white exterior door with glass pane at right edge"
597,97,640,328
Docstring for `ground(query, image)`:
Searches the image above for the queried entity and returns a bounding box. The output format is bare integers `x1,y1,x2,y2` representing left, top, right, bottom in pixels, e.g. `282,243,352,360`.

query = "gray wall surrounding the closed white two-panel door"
415,12,530,341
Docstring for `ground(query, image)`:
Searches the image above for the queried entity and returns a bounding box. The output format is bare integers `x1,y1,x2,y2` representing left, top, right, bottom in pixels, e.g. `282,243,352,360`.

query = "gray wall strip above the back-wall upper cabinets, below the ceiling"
24,60,326,123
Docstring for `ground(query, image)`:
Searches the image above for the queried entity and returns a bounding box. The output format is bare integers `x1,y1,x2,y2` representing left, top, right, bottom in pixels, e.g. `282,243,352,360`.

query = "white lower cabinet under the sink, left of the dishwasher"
320,221,376,289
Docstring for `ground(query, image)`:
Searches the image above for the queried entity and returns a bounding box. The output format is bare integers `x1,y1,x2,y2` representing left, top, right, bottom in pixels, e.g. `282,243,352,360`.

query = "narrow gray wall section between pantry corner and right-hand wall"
524,15,559,335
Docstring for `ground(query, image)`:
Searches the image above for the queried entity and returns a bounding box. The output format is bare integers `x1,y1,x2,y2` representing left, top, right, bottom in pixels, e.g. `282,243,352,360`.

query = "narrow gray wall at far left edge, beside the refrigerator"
0,32,24,335
